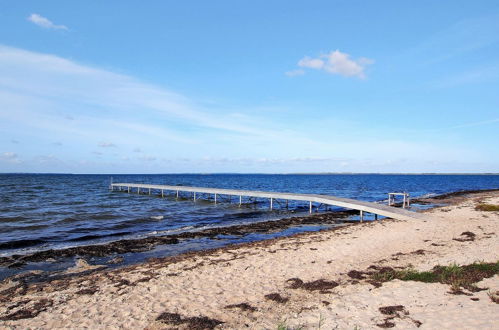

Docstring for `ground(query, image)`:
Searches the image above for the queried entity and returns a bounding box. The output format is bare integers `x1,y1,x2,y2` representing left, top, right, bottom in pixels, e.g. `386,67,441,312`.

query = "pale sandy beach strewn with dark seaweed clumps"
0,192,499,329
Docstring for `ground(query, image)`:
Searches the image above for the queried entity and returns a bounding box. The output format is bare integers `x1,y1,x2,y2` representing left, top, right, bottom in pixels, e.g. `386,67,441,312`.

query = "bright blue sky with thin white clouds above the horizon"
0,0,499,173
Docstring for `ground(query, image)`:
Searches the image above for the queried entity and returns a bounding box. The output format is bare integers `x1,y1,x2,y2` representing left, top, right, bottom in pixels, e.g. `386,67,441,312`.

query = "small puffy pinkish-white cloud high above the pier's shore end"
298,50,374,79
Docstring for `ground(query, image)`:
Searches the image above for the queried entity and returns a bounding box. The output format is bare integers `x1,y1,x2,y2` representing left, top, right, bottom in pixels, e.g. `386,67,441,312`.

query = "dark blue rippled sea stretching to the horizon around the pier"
0,174,499,278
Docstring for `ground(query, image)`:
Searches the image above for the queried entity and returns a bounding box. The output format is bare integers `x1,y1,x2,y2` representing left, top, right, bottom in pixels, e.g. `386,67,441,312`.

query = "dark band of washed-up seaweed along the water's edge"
0,189,499,278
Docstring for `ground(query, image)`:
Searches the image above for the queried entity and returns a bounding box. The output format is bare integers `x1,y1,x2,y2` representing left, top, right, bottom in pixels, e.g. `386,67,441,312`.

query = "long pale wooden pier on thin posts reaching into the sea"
110,183,428,221
